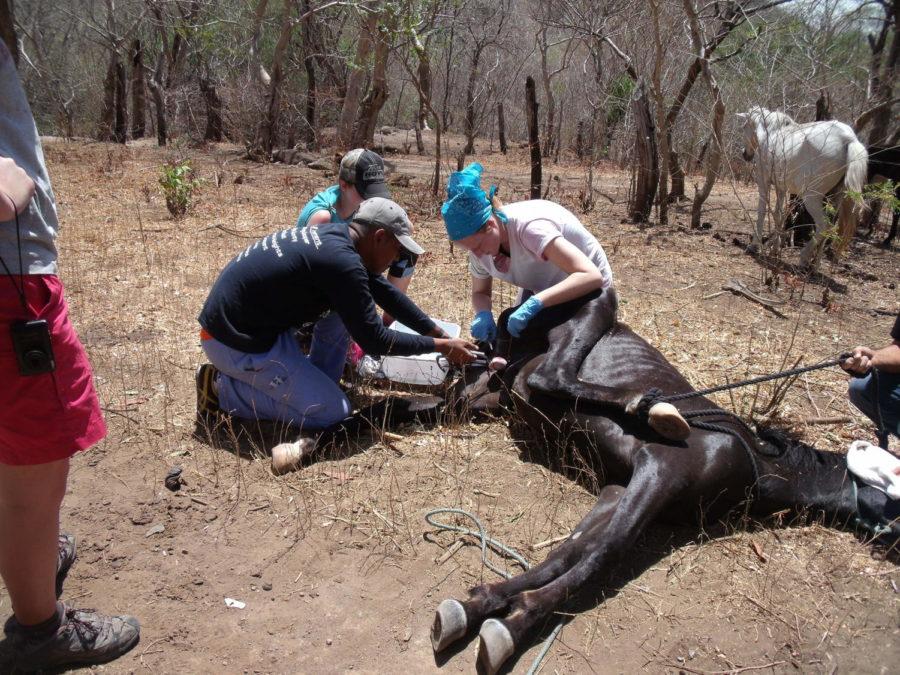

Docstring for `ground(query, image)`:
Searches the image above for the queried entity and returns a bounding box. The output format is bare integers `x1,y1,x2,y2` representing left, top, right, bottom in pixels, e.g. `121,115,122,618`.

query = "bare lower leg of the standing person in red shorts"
0,459,69,626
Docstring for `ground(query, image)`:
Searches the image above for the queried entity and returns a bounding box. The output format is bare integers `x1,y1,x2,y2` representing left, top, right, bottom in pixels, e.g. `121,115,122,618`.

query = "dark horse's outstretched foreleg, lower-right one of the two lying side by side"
478,446,688,673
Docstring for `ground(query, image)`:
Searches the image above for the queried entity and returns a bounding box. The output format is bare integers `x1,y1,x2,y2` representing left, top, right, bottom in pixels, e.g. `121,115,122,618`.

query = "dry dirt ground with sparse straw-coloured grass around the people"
8,133,900,674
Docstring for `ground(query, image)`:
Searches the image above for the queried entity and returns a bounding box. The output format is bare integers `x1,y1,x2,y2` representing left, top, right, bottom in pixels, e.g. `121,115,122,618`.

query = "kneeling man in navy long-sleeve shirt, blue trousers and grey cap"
197,197,474,431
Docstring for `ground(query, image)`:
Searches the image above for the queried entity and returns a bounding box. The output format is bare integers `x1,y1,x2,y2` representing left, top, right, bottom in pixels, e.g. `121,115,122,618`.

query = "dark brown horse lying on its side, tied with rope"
432,291,900,673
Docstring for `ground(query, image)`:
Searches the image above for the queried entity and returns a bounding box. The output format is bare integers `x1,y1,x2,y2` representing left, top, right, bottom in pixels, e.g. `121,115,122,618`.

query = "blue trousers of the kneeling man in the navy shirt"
203,312,352,431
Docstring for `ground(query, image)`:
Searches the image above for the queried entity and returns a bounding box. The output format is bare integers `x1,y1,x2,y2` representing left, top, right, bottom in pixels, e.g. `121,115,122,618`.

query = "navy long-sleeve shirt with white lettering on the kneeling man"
198,223,435,356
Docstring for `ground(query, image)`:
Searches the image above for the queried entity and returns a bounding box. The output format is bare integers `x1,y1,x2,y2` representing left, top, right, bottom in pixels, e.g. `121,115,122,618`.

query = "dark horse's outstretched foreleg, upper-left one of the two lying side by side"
431,485,625,652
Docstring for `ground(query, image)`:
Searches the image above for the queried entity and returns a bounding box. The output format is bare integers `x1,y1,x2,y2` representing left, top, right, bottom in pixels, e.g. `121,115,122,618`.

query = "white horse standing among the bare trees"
737,106,868,266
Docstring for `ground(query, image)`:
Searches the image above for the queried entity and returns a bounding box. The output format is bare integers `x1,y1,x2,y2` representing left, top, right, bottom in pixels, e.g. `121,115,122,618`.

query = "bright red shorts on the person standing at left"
0,275,106,465
